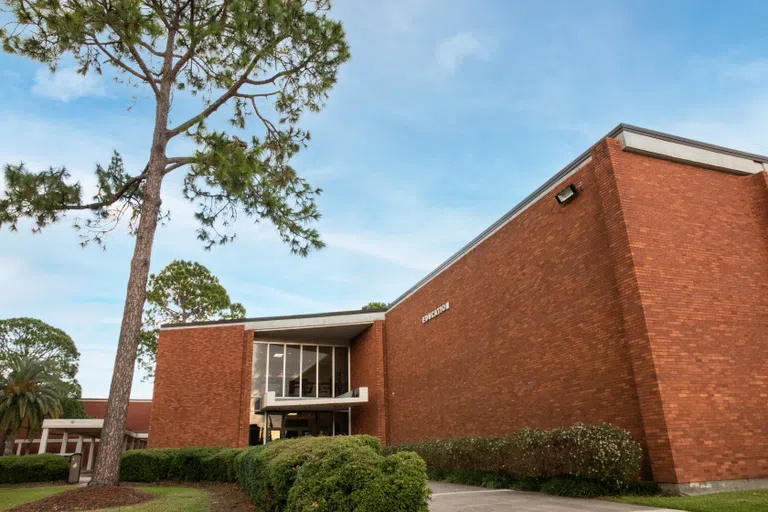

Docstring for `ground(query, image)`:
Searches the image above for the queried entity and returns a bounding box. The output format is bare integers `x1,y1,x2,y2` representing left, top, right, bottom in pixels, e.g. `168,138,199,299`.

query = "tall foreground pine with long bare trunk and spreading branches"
0,0,349,486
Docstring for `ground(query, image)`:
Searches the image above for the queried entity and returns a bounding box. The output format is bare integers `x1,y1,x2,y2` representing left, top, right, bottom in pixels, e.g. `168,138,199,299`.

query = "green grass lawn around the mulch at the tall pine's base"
0,485,210,512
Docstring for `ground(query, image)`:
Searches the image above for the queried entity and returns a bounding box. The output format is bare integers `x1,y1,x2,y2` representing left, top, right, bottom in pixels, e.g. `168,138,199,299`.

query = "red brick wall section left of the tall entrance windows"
149,325,253,448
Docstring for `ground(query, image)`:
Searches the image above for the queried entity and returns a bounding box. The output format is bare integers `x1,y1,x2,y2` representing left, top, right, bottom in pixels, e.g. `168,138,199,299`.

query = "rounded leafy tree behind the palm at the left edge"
0,318,85,446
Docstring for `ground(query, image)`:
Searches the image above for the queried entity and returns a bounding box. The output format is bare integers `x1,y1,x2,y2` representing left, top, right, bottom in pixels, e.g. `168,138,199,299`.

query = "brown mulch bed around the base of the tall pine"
9,486,154,512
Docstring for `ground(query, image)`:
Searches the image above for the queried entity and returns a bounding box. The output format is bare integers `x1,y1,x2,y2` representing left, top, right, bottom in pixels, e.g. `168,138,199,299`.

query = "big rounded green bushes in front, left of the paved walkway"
236,436,430,512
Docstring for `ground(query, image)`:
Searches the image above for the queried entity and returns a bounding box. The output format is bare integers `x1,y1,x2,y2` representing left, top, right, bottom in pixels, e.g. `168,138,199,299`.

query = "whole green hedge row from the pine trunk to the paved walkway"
120,436,430,512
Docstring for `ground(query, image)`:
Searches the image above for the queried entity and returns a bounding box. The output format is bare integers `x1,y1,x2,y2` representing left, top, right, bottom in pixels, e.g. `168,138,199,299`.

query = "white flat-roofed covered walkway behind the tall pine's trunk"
16,419,149,471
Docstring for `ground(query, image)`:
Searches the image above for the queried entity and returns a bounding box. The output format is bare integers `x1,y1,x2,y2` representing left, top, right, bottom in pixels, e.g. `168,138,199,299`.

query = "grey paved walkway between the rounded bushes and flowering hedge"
429,482,669,512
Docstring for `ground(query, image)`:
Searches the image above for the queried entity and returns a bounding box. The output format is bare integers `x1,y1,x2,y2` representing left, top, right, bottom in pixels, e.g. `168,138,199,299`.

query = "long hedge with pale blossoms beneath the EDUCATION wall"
387,424,642,496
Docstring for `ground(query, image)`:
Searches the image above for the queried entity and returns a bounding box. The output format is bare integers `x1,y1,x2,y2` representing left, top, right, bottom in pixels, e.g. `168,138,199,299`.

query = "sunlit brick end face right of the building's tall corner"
607,140,768,482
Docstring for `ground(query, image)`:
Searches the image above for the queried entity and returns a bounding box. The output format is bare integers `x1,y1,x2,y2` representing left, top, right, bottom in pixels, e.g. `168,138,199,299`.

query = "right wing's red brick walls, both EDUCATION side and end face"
386,139,768,483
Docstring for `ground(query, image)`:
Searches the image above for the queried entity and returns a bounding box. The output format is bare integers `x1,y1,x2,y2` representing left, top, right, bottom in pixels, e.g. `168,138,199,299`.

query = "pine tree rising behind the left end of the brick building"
139,260,245,378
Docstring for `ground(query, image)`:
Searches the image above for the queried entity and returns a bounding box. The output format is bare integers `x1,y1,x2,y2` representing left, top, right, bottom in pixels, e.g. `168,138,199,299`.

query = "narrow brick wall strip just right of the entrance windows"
350,321,387,443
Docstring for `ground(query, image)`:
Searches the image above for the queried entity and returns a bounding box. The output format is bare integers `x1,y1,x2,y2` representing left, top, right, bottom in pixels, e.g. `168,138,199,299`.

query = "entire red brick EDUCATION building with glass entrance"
150,125,768,490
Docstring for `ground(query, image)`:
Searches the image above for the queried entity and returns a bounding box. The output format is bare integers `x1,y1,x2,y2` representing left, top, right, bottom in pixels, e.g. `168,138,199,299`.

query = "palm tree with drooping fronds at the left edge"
0,355,66,455
